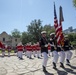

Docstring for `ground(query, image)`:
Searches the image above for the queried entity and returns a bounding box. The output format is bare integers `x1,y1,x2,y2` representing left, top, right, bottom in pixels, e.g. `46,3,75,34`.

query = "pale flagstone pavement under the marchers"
0,50,76,75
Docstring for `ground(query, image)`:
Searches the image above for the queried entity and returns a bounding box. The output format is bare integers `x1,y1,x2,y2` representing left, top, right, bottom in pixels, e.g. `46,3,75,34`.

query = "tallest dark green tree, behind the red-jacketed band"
27,19,43,42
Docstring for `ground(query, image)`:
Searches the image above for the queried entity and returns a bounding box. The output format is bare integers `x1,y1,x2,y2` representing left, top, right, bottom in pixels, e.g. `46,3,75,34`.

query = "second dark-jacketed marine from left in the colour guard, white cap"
49,33,59,69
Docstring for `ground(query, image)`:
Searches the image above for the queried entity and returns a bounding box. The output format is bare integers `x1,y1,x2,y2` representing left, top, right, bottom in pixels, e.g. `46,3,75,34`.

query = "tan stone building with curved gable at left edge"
0,32,21,47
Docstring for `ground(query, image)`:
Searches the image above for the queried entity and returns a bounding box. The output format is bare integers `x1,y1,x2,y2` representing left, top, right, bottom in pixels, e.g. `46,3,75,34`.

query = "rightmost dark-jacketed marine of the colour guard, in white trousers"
64,35,72,65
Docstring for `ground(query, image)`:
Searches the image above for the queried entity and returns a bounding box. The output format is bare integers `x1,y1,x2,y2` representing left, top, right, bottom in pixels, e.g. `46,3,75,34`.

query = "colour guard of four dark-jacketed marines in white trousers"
40,31,72,72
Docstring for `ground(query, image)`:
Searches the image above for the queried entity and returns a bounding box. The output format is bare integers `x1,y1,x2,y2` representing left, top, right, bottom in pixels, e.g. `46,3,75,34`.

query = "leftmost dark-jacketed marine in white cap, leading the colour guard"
40,31,48,72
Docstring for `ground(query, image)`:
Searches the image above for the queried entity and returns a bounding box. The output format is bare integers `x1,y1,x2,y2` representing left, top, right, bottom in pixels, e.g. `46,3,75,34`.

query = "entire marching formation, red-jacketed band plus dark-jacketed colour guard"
0,31,72,72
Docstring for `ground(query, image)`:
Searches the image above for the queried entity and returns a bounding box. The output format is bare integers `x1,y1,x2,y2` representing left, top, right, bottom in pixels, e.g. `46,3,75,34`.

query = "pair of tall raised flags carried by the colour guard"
54,3,64,45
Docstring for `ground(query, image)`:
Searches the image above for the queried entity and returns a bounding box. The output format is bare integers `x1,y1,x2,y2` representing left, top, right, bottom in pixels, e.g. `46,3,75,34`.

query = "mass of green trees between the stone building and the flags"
12,19,55,44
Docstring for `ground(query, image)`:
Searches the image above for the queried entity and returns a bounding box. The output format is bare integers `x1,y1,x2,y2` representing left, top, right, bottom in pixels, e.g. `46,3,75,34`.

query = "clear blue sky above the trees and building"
0,0,76,34
